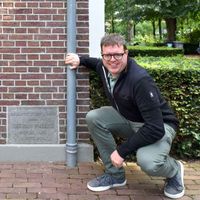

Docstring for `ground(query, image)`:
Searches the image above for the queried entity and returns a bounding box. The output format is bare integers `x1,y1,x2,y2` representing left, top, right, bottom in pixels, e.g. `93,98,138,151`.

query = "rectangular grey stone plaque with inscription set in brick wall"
8,107,58,144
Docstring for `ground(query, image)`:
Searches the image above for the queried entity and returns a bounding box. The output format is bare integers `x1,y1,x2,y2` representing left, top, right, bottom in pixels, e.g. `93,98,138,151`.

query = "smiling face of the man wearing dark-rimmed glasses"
101,45,128,76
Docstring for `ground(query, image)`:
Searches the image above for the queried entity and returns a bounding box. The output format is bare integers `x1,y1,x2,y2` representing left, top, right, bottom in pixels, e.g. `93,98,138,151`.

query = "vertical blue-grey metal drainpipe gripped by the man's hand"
66,0,78,167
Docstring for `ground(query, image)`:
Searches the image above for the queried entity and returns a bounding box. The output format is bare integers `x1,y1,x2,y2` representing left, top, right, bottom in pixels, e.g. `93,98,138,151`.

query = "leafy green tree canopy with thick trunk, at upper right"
105,0,200,41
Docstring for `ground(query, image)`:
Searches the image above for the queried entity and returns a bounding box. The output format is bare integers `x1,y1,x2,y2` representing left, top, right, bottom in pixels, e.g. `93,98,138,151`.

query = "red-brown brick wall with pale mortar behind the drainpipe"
0,0,89,144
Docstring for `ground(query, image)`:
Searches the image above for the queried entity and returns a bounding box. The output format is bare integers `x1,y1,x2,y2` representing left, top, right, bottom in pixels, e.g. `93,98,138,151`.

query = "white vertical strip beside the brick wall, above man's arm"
89,0,105,57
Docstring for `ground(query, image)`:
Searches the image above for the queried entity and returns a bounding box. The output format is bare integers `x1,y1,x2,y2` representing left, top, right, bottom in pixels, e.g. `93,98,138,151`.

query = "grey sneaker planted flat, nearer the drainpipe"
87,174,126,192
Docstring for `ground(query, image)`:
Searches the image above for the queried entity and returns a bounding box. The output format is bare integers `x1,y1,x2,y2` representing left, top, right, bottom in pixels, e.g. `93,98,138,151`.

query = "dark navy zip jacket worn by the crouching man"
80,57,178,158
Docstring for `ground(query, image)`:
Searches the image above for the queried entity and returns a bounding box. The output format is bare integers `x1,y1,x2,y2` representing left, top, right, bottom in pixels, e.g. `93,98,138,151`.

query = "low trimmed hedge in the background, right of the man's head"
127,46,184,57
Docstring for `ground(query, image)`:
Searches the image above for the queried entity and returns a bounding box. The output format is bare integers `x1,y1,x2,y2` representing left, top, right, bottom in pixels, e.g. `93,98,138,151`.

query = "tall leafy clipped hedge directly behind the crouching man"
90,56,200,159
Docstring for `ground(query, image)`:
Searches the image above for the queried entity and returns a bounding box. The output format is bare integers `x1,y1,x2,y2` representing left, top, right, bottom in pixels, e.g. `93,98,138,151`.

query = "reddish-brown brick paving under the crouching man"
0,161,200,200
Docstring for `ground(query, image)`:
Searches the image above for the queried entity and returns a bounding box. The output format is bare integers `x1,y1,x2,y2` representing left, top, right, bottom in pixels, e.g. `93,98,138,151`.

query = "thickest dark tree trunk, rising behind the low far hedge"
165,18,176,42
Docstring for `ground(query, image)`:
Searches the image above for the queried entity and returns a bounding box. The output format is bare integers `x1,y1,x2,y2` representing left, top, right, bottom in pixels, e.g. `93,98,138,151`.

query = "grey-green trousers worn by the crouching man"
86,106,178,178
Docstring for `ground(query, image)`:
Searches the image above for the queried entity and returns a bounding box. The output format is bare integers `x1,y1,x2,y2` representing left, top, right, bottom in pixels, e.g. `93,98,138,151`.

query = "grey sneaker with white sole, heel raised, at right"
164,161,185,199
